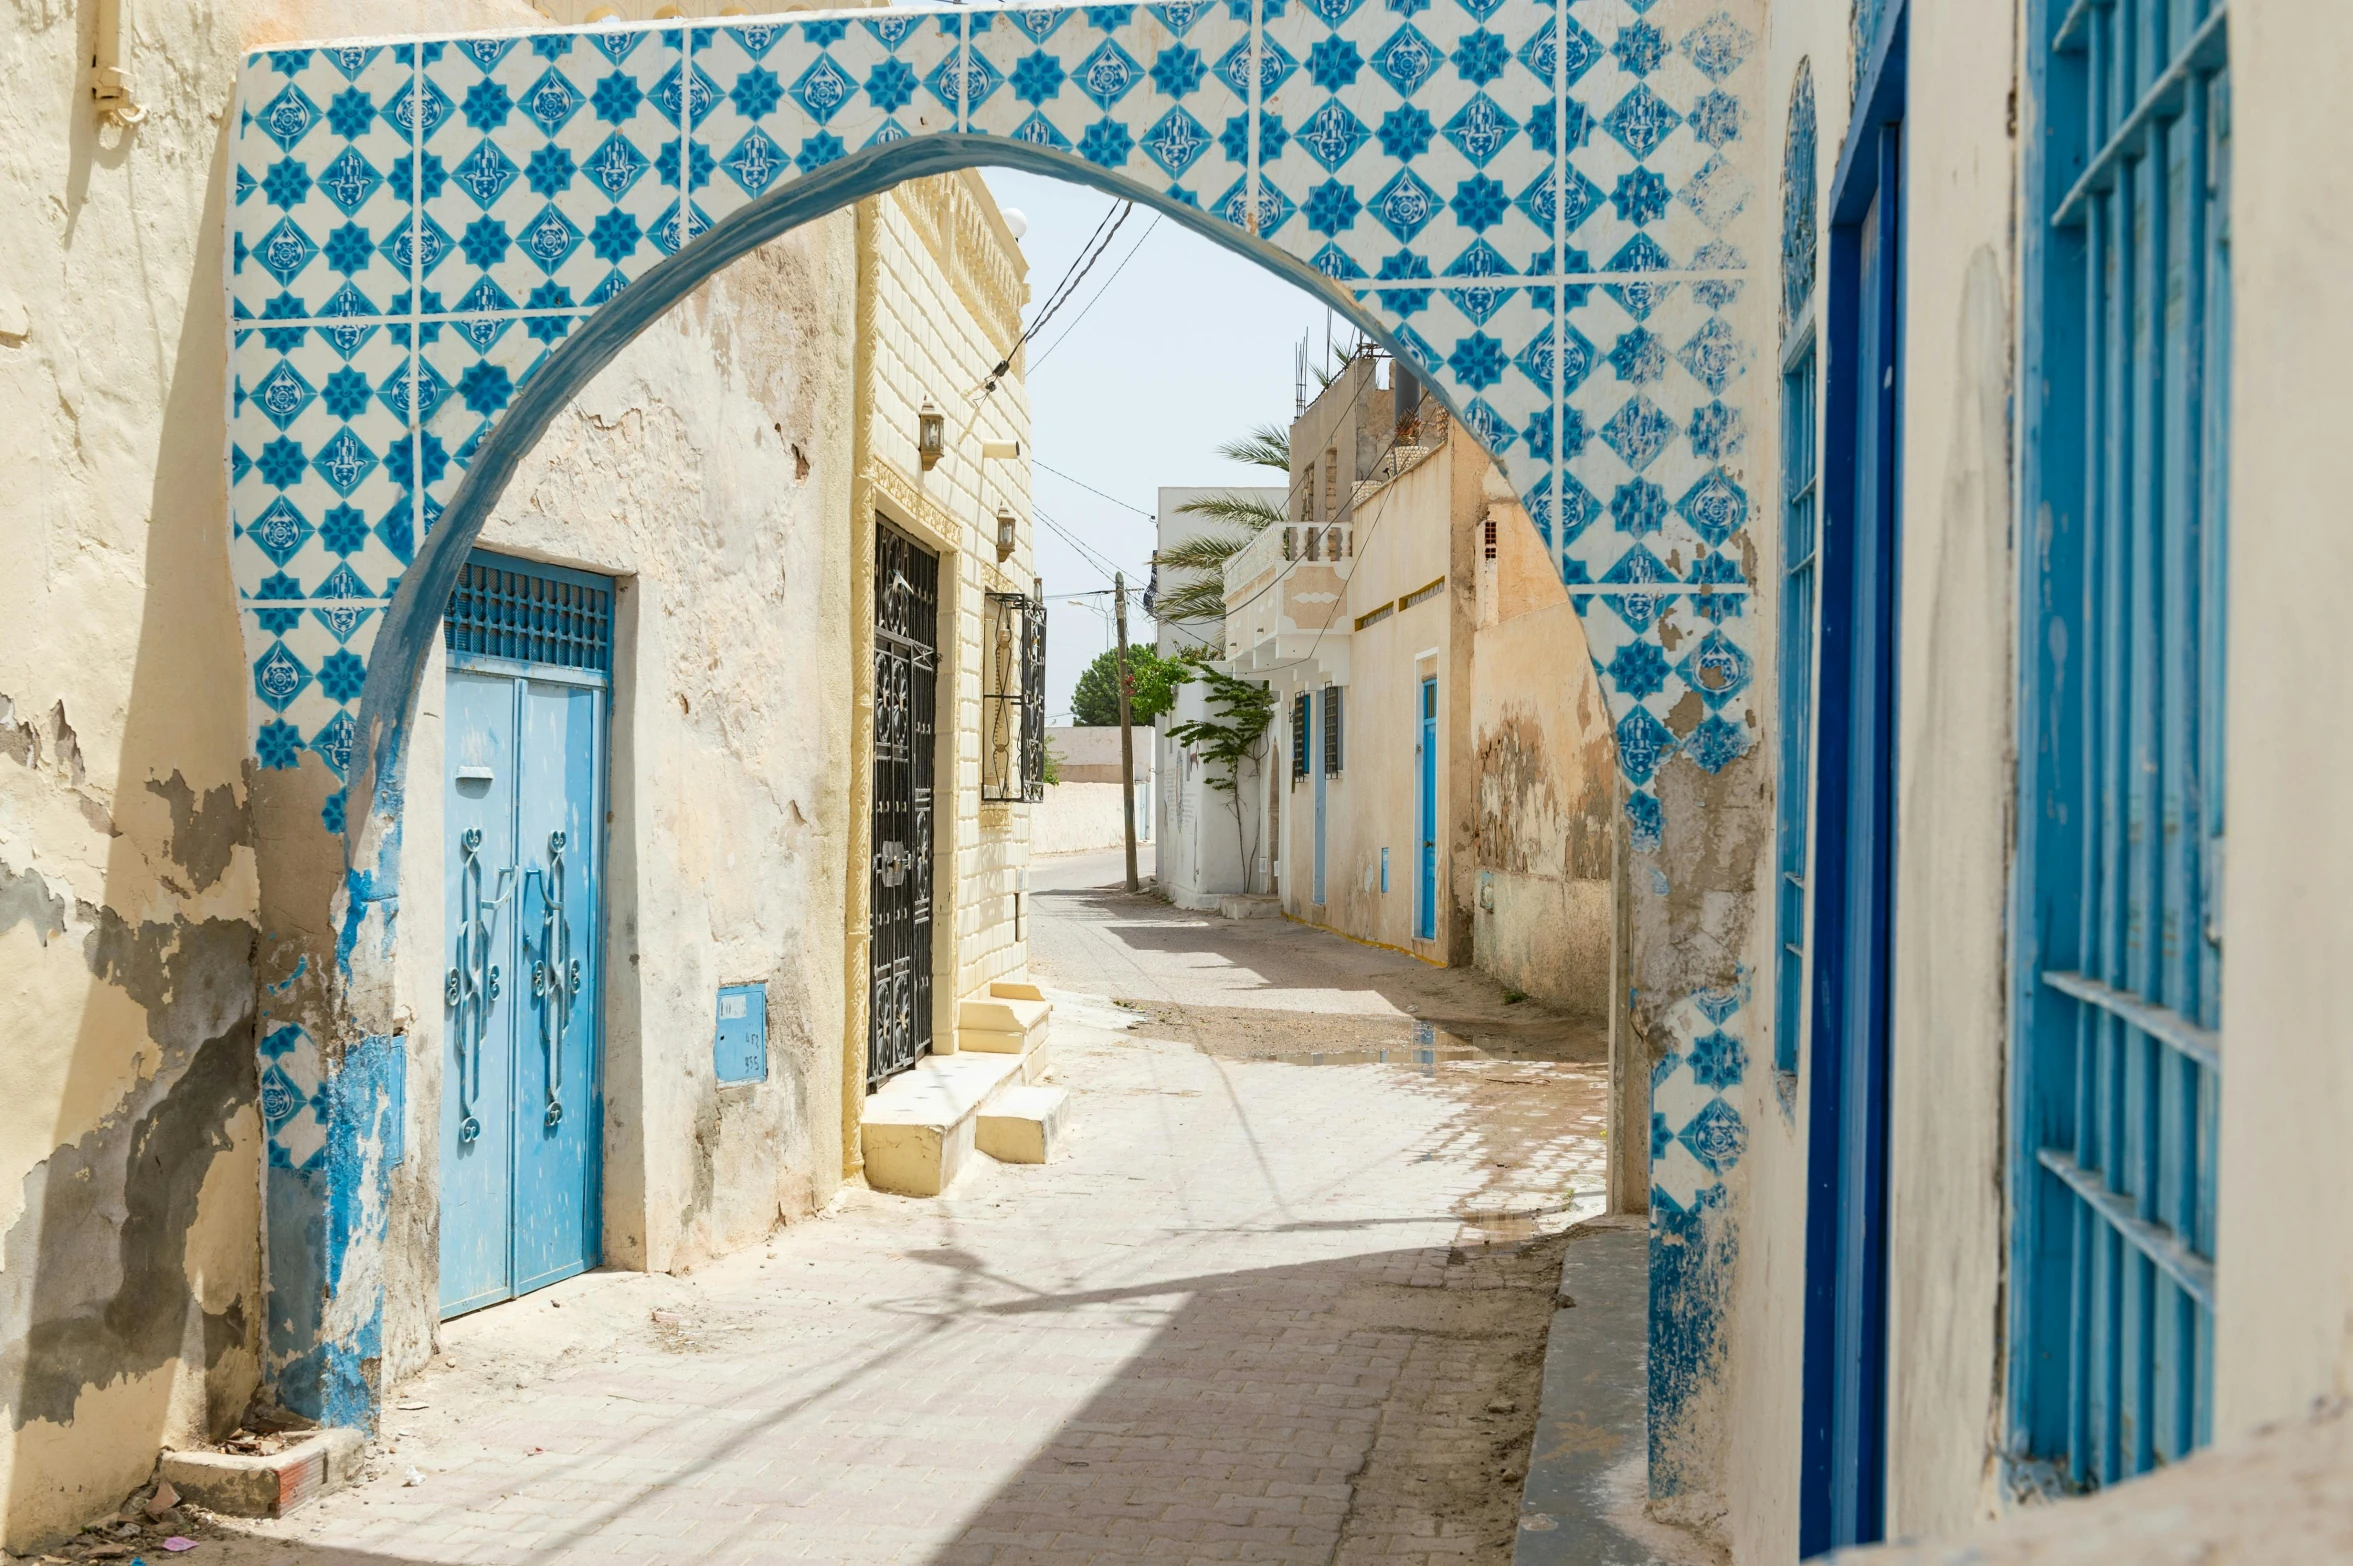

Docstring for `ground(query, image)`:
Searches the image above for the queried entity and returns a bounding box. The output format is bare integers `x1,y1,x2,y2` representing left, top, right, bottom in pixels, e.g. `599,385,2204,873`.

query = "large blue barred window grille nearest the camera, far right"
2009,0,2231,1488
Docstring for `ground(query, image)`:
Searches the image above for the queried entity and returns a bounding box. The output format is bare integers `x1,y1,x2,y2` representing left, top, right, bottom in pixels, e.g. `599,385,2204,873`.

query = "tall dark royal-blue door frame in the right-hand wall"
1798,5,1906,1557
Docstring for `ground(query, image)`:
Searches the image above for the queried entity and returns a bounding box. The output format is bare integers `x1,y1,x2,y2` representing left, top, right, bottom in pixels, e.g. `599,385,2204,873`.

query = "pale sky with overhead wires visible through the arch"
986,169,1353,722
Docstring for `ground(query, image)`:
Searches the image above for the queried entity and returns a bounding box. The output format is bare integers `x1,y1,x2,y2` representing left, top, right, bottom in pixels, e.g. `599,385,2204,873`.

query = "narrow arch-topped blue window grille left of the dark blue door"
1772,61,1821,1072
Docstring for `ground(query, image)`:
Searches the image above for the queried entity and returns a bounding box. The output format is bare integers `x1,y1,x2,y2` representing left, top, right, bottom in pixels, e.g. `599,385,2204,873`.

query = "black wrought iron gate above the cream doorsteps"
866,517,939,1089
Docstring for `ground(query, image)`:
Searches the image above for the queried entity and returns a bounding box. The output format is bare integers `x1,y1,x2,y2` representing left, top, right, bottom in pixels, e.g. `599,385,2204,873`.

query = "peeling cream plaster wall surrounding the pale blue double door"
384,212,854,1376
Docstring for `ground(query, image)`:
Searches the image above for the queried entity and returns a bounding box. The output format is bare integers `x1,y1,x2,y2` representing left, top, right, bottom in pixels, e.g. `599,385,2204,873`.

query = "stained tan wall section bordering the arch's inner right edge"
1464,468,1617,1018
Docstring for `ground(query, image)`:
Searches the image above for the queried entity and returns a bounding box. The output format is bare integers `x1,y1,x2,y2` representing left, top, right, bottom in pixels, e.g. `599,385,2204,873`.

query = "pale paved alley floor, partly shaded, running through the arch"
183,854,1605,1566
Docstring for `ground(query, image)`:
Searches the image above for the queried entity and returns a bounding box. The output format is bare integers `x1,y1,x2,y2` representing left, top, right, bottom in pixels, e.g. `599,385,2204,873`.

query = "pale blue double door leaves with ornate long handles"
440,616,605,1319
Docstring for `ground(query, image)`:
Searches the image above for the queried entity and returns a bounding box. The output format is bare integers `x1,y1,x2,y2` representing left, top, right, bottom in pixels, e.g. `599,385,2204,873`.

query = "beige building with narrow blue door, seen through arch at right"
1177,355,1612,1016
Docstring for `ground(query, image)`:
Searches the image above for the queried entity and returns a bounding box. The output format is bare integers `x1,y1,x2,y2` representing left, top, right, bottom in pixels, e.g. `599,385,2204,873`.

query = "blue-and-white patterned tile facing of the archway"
228,0,1755,1199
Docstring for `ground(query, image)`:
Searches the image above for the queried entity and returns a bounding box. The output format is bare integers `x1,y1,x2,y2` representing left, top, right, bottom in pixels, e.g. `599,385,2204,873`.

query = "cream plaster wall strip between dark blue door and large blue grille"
1887,5,2019,1538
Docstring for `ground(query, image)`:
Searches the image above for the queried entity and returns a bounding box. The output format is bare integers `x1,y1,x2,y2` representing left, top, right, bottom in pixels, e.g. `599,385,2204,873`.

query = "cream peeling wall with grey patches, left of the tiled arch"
0,5,472,1550
